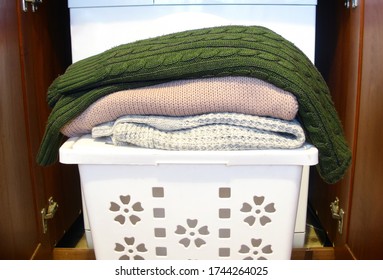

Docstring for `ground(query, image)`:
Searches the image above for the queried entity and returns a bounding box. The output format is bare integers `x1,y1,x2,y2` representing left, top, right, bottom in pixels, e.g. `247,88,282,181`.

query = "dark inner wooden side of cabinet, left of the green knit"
19,1,81,249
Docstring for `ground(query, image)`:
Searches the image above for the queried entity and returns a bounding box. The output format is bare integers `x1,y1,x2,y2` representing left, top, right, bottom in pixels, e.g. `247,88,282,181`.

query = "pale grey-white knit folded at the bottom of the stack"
92,113,305,151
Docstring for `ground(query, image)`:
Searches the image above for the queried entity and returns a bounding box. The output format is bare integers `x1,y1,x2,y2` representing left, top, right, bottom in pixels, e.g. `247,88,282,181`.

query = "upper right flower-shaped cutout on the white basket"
240,195,276,226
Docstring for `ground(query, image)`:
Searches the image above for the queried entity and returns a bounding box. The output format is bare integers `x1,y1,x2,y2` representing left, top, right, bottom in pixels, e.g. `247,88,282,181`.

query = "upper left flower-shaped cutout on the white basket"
109,195,144,225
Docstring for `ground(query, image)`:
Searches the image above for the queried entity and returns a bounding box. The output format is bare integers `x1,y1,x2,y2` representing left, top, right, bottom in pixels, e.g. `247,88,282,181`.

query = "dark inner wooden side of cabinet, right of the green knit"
309,0,364,258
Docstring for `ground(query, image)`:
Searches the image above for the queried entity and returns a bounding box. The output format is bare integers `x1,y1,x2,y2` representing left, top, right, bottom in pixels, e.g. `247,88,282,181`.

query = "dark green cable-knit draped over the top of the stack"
37,26,351,183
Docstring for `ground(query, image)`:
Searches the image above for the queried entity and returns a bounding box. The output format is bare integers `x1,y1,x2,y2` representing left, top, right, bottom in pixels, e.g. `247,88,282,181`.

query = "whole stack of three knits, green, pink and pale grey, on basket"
37,26,351,183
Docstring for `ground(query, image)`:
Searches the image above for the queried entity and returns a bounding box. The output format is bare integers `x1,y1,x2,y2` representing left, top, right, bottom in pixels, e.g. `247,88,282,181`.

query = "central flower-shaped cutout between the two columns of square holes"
175,219,210,248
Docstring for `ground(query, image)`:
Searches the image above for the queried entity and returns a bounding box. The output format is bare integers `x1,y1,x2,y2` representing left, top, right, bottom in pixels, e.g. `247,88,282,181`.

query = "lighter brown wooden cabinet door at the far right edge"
347,0,383,260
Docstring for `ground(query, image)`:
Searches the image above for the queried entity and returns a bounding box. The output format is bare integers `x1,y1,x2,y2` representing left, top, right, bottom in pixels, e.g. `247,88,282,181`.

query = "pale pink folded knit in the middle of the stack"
61,77,298,137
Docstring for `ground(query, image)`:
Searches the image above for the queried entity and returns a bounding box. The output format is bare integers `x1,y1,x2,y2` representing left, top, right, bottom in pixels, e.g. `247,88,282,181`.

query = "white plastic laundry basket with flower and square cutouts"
60,136,318,260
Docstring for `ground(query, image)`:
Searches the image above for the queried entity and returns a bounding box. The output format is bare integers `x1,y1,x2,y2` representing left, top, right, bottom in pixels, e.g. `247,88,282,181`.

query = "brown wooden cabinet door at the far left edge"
0,1,40,259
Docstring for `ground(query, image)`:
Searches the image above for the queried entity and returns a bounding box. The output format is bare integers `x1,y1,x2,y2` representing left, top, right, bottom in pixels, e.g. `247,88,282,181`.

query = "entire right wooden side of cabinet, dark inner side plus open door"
310,0,383,259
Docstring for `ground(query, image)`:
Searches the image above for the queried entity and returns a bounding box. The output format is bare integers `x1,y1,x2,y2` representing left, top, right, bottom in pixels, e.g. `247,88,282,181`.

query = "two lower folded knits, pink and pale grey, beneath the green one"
61,76,305,150
